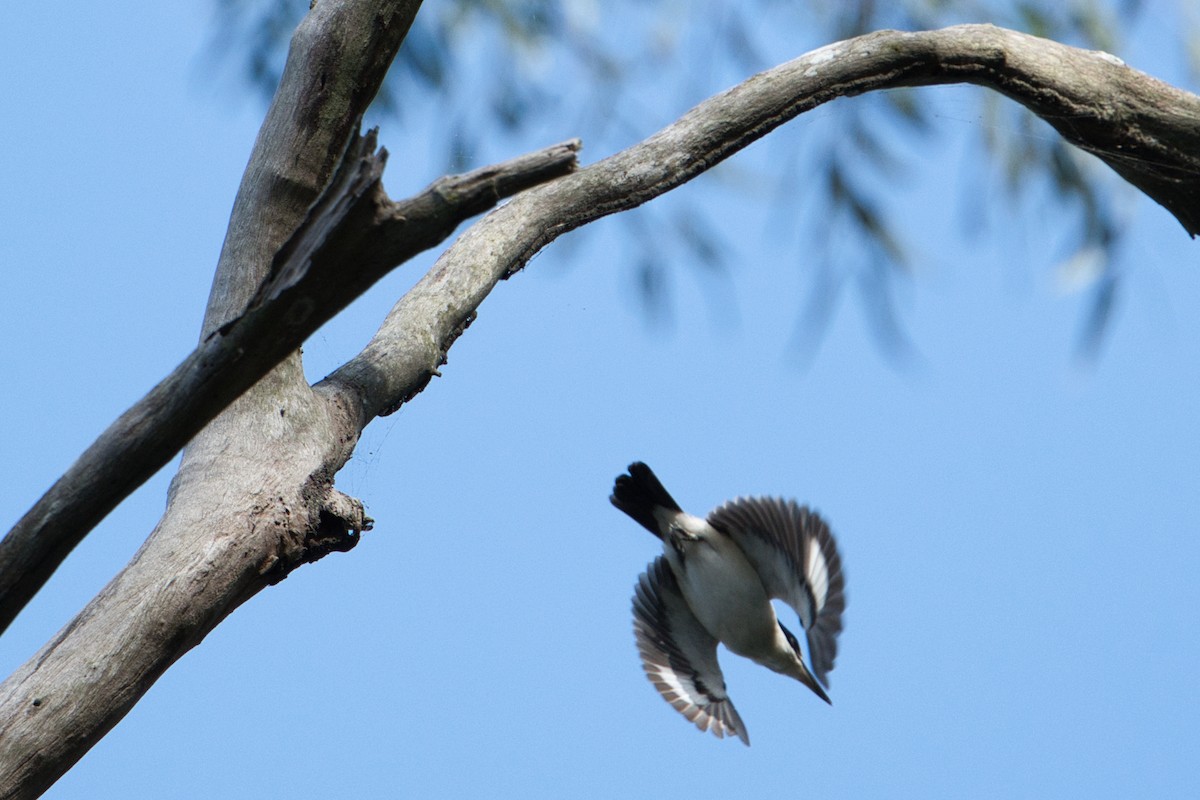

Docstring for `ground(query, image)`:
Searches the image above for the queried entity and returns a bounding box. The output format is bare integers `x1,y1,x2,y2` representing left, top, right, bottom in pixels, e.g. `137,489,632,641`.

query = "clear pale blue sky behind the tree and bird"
0,2,1200,799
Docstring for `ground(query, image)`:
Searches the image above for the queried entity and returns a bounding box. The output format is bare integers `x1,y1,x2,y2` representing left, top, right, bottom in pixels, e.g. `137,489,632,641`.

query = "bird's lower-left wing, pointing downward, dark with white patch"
634,557,750,745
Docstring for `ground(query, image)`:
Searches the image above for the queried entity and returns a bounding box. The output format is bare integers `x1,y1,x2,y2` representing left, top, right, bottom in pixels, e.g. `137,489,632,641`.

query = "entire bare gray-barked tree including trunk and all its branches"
0,9,1200,798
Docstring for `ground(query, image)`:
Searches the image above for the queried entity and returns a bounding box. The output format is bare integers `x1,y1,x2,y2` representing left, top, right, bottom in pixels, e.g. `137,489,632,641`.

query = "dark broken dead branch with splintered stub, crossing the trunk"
0,132,578,631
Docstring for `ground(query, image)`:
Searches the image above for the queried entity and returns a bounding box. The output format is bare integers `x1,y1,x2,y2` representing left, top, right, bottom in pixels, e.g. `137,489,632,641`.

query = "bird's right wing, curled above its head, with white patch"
708,498,846,686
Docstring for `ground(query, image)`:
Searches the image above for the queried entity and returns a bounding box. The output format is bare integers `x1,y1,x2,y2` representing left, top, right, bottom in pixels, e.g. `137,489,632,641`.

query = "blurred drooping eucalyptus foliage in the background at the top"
214,0,1171,359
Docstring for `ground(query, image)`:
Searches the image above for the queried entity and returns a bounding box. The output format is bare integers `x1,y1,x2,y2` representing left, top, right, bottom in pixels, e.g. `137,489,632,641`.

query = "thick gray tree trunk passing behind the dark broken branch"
0,0,420,798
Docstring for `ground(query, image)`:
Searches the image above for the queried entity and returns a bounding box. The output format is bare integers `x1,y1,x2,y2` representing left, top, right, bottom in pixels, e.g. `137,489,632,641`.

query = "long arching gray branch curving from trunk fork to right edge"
326,25,1200,419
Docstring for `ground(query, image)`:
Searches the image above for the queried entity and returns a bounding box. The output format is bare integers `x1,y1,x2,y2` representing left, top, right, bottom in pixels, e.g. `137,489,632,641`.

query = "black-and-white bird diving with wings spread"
608,462,846,745
